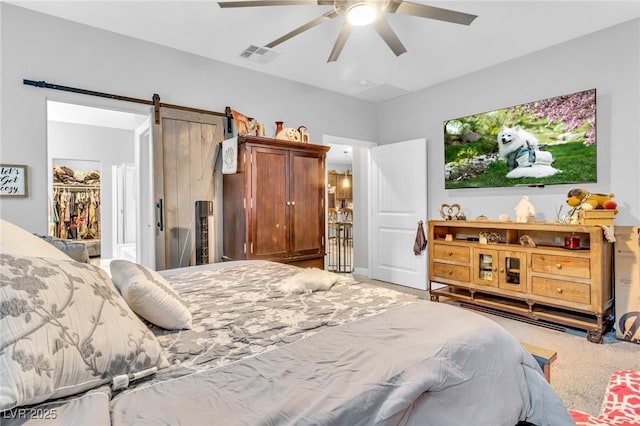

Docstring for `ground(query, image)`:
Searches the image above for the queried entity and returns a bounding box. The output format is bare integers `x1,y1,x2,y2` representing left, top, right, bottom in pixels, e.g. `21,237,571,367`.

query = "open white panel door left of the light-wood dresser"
370,139,427,290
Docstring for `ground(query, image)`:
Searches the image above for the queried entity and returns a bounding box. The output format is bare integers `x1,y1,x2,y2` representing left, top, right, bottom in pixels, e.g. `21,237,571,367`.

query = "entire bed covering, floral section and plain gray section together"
2,261,574,426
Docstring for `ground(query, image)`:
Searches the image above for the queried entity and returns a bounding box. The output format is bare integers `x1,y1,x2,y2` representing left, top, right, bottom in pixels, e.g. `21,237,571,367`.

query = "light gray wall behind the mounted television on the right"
376,19,640,225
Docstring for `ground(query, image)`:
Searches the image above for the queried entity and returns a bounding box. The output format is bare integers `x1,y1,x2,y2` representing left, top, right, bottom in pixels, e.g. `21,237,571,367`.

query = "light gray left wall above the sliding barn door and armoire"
0,2,377,233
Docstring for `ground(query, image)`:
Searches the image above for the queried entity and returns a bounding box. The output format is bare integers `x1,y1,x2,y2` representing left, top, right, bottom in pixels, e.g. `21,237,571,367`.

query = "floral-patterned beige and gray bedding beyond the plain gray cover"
149,261,417,380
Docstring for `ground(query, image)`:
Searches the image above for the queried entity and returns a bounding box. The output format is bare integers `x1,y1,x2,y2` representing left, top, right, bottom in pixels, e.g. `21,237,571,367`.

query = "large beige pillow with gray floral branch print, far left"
0,255,168,411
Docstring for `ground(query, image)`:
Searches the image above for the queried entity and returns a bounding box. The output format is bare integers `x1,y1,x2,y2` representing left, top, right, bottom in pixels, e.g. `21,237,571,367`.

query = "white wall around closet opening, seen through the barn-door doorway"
48,121,135,258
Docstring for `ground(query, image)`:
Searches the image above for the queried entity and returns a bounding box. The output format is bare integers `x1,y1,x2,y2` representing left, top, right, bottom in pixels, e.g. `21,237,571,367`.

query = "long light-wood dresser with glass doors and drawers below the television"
429,220,613,343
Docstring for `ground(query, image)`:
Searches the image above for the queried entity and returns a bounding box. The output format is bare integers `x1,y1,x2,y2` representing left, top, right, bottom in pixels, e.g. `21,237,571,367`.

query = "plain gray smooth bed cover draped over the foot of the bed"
112,301,573,426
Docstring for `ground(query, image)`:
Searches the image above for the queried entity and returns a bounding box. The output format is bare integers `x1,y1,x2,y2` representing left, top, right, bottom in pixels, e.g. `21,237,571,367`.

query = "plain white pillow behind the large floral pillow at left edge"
0,219,71,260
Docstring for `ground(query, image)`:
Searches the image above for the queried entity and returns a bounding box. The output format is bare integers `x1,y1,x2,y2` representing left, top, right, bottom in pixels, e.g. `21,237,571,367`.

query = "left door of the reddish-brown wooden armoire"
252,149,289,259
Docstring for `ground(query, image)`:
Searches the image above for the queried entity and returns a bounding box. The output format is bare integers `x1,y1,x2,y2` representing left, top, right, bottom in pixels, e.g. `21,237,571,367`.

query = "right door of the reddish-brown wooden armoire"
290,152,324,256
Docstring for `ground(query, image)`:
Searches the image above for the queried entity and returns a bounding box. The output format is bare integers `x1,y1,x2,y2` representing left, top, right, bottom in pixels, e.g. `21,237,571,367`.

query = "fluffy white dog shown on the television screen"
498,126,560,178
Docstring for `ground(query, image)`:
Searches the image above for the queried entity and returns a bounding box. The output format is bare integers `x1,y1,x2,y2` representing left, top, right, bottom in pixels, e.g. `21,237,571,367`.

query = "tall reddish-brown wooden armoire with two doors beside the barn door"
223,136,329,269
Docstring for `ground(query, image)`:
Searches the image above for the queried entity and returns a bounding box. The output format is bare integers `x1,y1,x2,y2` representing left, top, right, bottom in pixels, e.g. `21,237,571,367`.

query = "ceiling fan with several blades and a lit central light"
218,0,477,62
